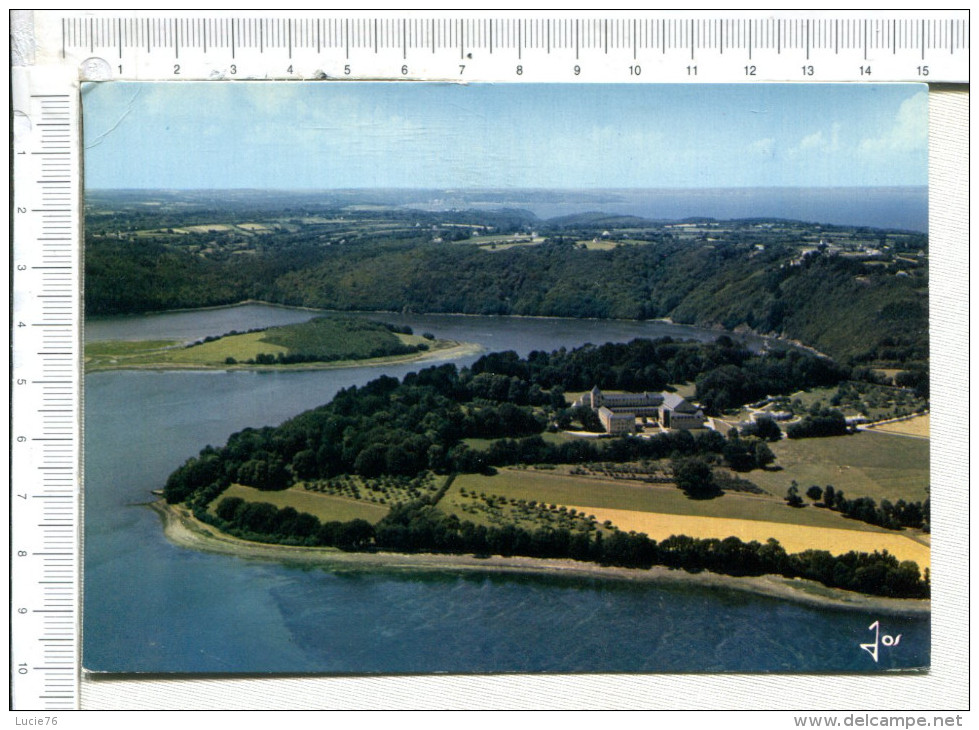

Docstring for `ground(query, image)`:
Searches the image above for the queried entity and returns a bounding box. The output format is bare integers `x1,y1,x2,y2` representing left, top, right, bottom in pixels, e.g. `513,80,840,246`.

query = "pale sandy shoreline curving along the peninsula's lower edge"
149,500,931,616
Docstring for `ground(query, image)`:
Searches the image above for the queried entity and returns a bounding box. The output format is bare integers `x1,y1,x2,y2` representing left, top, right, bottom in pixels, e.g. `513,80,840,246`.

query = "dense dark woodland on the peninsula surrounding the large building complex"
165,338,849,505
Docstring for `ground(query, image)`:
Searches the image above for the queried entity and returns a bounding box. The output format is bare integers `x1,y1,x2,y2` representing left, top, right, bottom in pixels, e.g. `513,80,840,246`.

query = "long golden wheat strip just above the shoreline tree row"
580,505,931,570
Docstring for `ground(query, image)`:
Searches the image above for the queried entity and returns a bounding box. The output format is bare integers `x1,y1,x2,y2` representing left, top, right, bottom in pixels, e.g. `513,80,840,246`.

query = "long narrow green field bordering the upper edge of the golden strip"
439,469,896,532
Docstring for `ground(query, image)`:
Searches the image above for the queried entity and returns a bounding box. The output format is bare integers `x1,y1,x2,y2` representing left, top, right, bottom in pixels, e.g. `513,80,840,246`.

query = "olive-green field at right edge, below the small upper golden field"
748,431,929,502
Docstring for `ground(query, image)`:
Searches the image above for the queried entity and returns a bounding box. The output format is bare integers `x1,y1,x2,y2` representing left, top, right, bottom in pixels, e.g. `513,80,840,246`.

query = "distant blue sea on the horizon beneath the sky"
412,186,928,233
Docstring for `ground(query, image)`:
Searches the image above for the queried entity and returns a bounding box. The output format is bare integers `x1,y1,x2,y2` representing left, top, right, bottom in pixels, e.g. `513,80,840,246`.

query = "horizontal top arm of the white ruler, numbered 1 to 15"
28,12,969,82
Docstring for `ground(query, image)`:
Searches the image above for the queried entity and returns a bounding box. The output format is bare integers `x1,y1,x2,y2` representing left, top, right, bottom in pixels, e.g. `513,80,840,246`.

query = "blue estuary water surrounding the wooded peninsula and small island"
83,304,930,673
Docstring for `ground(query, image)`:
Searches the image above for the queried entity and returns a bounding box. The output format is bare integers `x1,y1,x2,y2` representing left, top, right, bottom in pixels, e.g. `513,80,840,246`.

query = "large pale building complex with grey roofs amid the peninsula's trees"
573,385,706,434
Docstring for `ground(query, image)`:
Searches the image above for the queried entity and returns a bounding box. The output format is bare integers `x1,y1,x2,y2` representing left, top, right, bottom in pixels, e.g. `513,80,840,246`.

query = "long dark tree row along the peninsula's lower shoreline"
197,498,930,598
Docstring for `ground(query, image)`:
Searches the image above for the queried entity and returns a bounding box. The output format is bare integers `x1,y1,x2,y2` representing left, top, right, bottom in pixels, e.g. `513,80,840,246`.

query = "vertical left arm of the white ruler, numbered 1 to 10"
10,69,81,710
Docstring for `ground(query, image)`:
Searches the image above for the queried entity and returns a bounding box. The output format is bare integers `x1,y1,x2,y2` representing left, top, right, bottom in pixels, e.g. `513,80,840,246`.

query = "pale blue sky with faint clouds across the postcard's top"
82,81,928,190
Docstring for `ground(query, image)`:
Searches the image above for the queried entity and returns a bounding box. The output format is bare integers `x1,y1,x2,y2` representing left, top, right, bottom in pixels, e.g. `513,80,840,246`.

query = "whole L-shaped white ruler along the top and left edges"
10,10,970,710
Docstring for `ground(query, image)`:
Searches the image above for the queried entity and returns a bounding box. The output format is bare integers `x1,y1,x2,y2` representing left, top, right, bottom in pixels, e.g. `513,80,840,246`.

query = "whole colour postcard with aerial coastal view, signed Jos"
81,81,931,675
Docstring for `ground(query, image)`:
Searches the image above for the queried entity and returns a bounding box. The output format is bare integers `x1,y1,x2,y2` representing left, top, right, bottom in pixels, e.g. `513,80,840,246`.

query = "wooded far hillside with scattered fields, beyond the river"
85,193,928,372
